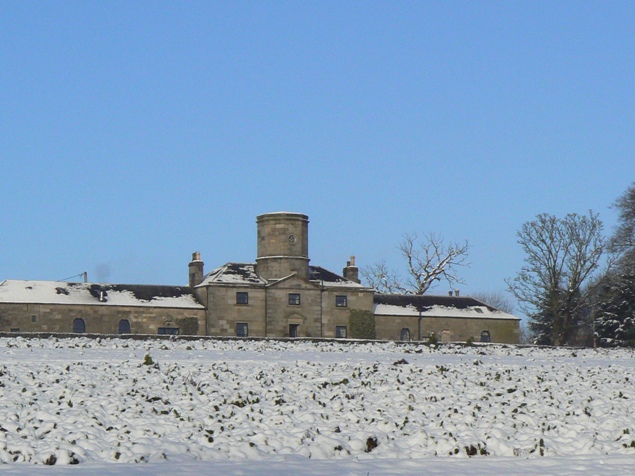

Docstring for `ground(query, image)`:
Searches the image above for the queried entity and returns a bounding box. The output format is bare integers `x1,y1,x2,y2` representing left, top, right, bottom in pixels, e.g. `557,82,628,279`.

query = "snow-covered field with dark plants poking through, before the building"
0,338,635,475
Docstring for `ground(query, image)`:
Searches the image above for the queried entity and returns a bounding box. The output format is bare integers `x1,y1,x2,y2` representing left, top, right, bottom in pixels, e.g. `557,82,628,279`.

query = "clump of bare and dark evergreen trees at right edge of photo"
506,182,635,346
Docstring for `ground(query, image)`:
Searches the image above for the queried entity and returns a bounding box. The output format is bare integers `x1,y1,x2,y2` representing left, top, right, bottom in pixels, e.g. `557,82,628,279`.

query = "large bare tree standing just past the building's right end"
506,211,607,345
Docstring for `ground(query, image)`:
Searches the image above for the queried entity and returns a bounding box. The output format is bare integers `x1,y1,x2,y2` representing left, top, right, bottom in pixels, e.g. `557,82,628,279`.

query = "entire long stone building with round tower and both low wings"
0,212,520,343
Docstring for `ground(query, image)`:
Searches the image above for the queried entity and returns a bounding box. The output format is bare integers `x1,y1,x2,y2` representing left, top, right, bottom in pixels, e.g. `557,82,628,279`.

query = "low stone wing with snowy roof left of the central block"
0,280,205,334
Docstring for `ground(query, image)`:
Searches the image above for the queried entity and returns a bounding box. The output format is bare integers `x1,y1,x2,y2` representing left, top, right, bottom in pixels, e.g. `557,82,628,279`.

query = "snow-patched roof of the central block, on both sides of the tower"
199,263,365,288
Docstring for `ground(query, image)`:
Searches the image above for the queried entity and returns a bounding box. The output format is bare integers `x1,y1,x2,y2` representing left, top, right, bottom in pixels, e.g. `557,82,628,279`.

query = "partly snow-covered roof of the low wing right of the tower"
374,294,520,320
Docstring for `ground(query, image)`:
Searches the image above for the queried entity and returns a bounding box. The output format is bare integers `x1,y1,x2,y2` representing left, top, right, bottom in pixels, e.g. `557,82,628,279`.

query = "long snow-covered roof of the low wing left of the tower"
0,280,203,309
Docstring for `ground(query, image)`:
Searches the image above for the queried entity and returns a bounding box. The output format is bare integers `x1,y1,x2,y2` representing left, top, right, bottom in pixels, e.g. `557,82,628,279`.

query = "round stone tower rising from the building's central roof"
256,212,309,280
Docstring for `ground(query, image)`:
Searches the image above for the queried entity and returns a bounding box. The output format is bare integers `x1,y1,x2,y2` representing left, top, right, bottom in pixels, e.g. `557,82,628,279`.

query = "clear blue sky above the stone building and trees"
0,1,635,308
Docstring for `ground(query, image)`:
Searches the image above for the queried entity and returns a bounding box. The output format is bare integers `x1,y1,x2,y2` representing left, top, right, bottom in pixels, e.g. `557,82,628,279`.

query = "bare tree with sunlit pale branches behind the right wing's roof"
361,234,469,294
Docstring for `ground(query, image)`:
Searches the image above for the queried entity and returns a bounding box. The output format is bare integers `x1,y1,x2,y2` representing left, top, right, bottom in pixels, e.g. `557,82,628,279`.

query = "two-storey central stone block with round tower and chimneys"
190,212,373,337
